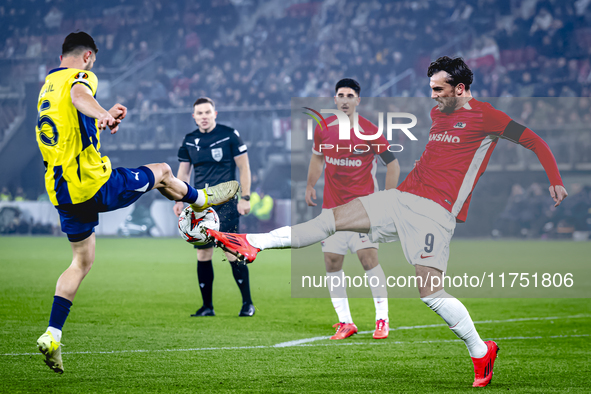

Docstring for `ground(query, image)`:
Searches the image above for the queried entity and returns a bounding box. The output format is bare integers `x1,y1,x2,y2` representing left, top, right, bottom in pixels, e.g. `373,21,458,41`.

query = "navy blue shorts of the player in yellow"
56,166,154,242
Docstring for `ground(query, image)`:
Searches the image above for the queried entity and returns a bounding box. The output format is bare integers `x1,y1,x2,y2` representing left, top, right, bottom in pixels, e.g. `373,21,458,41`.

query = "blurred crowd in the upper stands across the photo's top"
0,0,591,111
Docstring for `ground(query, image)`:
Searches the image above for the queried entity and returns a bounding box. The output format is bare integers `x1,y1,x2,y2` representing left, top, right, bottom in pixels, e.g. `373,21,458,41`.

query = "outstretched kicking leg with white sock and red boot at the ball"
207,199,370,263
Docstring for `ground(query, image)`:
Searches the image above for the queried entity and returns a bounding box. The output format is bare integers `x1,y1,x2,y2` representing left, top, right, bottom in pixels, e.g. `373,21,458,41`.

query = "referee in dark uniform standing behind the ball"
174,97,255,316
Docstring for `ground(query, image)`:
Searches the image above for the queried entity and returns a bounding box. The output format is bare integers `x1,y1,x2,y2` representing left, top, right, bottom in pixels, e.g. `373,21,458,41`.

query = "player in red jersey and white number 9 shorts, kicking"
209,56,568,387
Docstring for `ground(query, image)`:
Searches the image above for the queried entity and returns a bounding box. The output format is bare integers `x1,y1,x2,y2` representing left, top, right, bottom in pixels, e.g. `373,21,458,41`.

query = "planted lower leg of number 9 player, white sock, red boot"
415,265,499,387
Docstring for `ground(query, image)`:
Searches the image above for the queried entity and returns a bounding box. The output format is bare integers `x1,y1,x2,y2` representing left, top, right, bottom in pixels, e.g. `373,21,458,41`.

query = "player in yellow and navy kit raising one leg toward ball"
36,32,239,373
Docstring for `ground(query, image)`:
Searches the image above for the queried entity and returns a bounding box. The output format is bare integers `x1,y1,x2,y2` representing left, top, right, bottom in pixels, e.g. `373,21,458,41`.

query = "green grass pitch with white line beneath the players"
0,237,591,393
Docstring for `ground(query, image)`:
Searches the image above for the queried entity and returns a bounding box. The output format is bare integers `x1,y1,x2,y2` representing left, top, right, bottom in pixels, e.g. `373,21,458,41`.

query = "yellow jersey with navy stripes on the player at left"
36,68,111,205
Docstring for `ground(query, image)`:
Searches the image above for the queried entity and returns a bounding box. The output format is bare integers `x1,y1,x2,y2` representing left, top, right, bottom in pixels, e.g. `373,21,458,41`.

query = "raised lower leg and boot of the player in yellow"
145,163,240,211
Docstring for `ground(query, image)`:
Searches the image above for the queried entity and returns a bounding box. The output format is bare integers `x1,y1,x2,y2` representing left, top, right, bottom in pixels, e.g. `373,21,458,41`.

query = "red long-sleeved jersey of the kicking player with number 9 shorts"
398,99,562,222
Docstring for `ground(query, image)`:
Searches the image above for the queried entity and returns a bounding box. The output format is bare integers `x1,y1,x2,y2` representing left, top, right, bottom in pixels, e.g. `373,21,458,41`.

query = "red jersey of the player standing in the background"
312,115,388,209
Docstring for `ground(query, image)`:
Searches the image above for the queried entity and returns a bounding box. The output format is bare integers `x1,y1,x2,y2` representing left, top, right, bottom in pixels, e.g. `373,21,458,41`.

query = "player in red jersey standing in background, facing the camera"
306,78,400,339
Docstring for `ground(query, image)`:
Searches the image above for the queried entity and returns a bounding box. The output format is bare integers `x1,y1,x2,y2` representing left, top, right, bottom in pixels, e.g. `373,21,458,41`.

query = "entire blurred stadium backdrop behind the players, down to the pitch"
0,0,591,240
